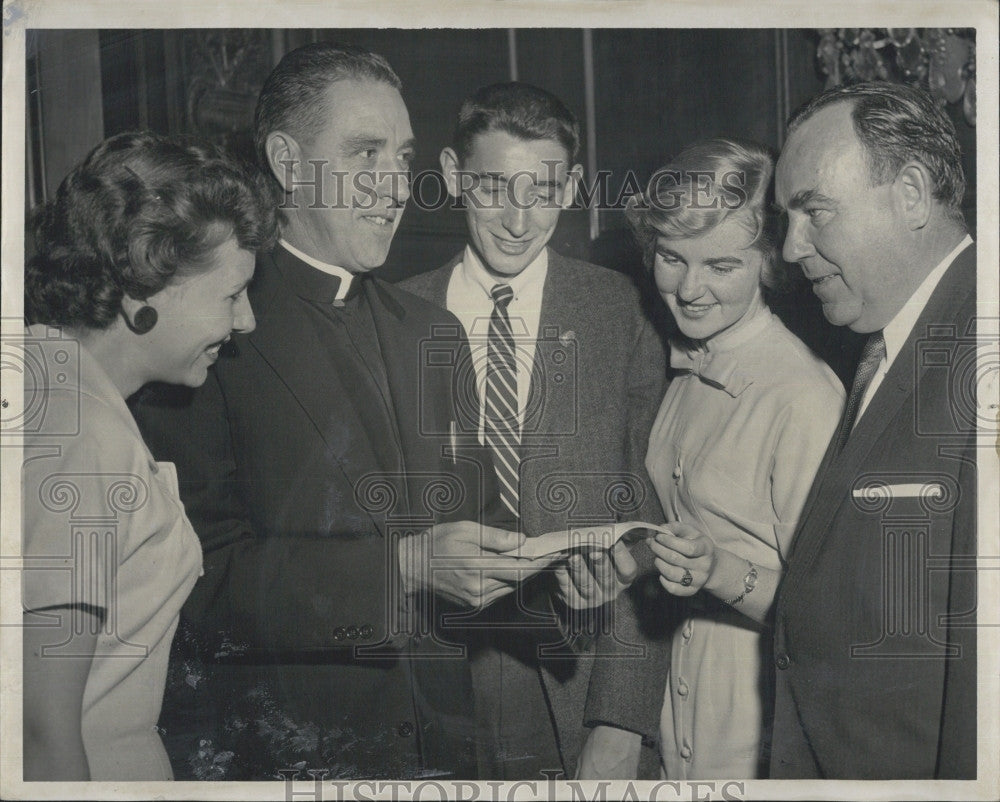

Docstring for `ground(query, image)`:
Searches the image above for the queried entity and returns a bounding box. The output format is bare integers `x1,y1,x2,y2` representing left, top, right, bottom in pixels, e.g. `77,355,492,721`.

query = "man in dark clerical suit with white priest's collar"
136,43,537,779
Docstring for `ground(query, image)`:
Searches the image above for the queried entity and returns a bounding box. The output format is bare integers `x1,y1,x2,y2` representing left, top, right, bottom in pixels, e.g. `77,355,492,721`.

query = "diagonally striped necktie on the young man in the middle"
483,284,521,519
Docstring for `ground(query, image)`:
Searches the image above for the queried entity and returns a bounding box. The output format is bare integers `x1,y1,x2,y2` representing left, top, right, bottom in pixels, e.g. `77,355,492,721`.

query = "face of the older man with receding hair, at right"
775,102,913,333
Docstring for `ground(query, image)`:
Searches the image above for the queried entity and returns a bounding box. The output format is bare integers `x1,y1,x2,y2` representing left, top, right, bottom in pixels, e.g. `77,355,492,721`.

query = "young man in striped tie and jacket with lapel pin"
403,82,666,780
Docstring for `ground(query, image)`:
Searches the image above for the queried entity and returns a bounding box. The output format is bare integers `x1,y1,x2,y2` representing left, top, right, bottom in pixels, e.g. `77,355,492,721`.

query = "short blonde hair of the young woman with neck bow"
625,138,790,291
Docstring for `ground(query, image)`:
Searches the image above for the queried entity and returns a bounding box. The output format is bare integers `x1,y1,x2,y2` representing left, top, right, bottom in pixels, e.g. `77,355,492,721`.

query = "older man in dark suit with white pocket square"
771,83,977,779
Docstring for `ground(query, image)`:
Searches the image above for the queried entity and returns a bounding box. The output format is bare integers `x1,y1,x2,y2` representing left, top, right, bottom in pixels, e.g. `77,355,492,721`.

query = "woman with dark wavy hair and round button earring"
22,133,275,780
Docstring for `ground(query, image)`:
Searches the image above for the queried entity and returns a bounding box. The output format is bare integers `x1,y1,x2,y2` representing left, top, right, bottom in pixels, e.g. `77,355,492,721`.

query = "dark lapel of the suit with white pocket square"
793,245,976,564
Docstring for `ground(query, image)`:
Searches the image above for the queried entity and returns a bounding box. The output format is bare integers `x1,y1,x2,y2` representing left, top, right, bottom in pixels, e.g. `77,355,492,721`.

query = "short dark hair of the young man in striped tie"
451,81,580,163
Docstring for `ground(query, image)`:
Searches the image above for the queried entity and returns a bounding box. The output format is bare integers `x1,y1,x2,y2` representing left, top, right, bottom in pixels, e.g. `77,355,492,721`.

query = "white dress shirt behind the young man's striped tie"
445,246,549,442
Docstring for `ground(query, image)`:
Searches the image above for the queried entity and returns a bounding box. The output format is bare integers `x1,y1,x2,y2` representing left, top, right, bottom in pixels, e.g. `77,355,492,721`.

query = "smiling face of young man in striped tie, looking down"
441,131,579,279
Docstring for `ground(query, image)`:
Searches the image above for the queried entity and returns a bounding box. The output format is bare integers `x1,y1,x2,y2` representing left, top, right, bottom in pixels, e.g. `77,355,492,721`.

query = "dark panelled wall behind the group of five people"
19,28,975,378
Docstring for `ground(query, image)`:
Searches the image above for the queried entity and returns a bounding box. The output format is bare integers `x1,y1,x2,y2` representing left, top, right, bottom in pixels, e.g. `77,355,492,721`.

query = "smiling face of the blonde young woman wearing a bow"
653,212,764,340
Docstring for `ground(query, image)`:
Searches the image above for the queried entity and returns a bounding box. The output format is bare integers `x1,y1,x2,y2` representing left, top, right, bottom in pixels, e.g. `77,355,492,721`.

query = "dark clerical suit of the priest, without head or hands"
135,248,495,779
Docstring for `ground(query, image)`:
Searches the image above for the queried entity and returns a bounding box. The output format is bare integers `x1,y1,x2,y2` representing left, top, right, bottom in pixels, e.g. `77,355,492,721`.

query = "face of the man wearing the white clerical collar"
269,79,414,273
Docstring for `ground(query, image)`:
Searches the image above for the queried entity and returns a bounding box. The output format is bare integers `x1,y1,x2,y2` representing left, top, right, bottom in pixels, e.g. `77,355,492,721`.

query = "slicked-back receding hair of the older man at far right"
788,81,965,224
